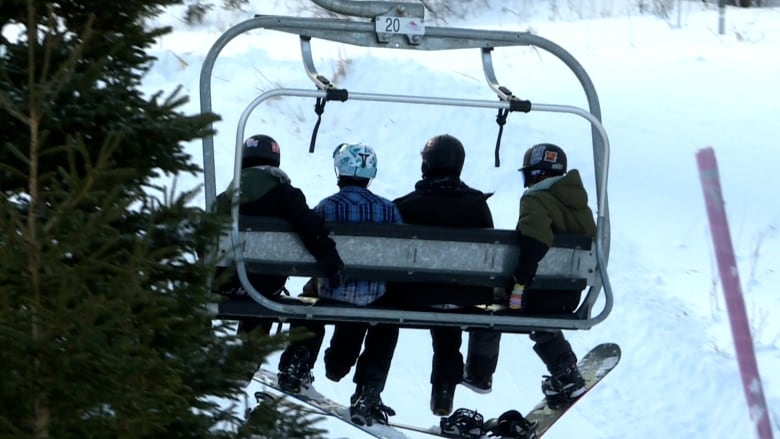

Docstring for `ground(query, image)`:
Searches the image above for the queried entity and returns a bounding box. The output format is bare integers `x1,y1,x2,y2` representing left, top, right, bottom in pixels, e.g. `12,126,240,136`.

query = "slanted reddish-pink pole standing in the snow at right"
696,147,772,439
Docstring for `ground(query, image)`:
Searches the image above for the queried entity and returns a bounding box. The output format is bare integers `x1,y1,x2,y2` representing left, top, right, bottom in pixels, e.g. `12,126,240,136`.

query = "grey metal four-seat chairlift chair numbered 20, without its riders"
200,0,613,333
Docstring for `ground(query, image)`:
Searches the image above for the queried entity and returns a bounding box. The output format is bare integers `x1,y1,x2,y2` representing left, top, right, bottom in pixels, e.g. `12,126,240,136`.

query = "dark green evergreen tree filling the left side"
0,0,317,438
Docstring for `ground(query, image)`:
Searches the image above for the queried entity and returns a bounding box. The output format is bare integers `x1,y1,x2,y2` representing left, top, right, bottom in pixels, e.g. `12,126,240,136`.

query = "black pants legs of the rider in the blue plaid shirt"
325,323,398,388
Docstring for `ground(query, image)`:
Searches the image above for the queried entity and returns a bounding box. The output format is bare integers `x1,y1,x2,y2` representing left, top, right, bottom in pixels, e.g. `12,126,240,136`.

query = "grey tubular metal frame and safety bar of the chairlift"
200,4,612,332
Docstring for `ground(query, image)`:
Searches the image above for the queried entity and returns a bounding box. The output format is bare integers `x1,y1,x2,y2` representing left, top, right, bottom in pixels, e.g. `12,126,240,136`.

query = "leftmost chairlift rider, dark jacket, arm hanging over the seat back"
216,134,344,340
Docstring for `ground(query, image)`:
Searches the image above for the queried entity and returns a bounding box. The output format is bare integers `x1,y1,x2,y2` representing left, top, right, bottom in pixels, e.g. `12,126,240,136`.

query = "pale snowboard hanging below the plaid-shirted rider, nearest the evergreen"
252,368,406,439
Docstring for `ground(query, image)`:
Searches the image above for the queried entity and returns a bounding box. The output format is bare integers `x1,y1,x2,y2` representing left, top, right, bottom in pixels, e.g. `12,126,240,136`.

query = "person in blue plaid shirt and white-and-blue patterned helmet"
279,143,402,425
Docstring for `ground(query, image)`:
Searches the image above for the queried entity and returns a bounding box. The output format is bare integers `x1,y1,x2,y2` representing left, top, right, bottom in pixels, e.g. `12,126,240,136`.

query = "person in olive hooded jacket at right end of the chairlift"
509,143,596,404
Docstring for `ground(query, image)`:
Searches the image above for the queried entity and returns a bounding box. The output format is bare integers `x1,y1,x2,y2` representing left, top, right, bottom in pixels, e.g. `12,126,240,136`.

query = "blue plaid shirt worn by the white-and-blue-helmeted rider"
314,186,403,306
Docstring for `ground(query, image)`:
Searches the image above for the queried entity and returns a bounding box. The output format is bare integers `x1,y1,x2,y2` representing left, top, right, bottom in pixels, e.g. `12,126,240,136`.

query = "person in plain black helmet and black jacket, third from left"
391,134,500,416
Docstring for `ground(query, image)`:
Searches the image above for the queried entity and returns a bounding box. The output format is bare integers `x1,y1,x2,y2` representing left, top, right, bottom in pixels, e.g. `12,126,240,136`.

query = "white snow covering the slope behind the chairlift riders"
143,0,780,439
